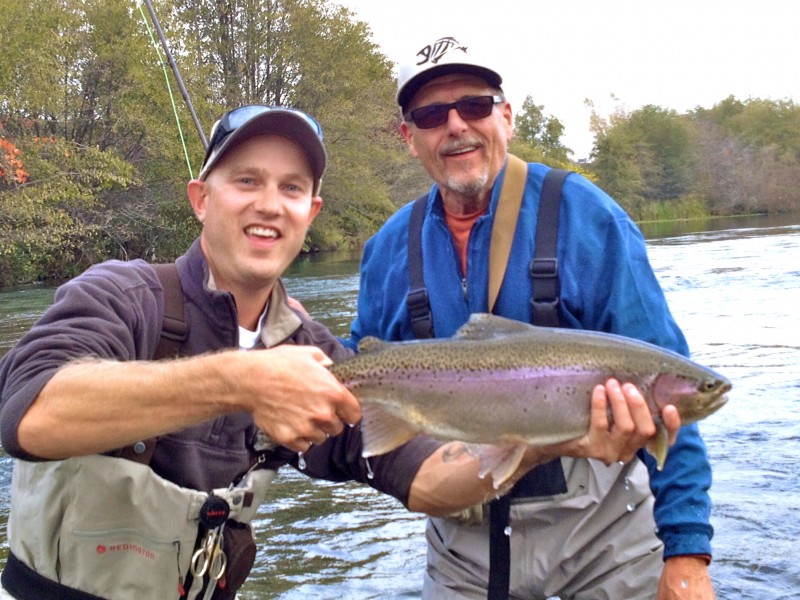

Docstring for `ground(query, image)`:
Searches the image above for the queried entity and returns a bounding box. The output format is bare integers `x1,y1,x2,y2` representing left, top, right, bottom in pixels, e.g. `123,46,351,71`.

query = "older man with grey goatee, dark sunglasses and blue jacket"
351,37,714,600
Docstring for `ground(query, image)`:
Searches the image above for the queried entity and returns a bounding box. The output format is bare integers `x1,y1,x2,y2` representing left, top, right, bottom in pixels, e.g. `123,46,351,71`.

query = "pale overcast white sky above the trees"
334,0,800,159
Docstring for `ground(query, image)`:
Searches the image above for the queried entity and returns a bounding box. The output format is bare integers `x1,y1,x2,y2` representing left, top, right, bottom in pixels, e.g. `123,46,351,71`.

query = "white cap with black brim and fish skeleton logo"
397,37,503,112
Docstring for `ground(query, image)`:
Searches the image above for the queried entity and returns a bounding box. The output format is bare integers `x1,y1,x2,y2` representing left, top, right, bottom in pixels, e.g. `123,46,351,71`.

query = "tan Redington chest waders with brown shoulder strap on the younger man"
2,264,275,600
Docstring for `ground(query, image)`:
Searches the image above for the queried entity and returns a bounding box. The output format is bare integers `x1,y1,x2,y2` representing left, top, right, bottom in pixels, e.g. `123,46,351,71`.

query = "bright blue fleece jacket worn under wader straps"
348,163,713,558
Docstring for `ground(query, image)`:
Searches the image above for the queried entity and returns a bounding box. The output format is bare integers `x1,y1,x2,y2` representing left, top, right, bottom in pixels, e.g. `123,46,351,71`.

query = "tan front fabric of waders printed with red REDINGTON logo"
8,455,275,600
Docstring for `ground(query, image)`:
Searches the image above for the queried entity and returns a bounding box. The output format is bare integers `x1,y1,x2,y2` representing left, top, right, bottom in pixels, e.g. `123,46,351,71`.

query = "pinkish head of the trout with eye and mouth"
651,369,731,425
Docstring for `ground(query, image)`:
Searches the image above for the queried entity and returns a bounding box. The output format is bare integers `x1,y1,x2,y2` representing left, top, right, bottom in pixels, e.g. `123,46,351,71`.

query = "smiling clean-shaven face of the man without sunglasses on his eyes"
189,134,322,296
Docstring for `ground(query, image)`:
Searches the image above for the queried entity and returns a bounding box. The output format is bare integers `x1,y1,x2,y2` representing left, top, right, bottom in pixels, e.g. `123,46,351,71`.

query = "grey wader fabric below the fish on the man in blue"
422,458,663,600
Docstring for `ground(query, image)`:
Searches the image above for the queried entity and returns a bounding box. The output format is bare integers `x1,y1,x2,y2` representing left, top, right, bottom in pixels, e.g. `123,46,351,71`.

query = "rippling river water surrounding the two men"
0,217,800,600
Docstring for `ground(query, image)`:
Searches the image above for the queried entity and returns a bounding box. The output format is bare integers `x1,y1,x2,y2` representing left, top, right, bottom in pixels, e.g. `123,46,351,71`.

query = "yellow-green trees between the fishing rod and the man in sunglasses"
166,0,410,249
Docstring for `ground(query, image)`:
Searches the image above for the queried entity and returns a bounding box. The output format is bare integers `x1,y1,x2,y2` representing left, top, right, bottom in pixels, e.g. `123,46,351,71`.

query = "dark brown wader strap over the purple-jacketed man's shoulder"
116,263,188,465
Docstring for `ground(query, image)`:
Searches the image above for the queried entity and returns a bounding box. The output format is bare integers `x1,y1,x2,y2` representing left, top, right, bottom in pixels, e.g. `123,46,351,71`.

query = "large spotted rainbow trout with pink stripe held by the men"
331,314,731,486
